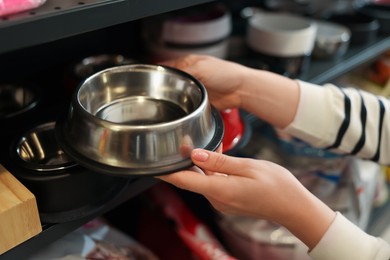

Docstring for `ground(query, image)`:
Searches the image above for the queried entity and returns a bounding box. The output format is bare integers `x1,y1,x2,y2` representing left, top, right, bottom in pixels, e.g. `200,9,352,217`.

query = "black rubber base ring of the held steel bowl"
55,107,224,177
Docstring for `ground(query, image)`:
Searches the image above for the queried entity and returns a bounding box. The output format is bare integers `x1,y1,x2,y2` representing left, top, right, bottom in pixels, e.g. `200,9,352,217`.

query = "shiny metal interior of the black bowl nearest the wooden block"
16,122,75,171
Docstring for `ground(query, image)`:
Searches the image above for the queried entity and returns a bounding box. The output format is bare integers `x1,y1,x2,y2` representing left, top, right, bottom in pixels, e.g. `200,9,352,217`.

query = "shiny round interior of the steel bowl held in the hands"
77,65,205,126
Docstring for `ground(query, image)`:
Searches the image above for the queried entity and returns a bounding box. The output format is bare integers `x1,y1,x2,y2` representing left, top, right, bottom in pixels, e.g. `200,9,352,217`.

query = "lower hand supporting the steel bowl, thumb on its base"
159,149,335,251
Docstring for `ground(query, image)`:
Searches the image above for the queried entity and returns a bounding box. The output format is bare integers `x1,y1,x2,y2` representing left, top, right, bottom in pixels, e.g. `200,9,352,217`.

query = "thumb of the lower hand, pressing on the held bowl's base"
191,148,247,175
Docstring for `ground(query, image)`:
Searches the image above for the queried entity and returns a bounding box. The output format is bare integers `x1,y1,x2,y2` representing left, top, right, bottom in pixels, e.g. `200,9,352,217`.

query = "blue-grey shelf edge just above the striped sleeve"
302,36,390,85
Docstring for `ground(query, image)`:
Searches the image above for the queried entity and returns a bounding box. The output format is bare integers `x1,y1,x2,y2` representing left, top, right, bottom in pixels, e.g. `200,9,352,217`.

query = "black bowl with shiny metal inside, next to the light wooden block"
7,122,128,223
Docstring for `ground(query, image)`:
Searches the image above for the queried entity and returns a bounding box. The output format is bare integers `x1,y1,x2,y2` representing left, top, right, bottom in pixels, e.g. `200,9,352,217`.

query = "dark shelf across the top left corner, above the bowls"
0,0,211,54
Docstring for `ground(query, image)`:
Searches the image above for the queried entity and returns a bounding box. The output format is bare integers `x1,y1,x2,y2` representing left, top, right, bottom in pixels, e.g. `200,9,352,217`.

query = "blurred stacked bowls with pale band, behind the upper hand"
143,3,232,61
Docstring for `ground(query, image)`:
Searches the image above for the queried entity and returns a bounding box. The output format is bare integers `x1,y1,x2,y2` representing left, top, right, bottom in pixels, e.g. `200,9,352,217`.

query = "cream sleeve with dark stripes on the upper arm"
284,81,390,165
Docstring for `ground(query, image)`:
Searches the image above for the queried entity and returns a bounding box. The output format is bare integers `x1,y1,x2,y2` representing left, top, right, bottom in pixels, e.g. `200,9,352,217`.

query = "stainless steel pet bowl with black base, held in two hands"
56,64,223,175
